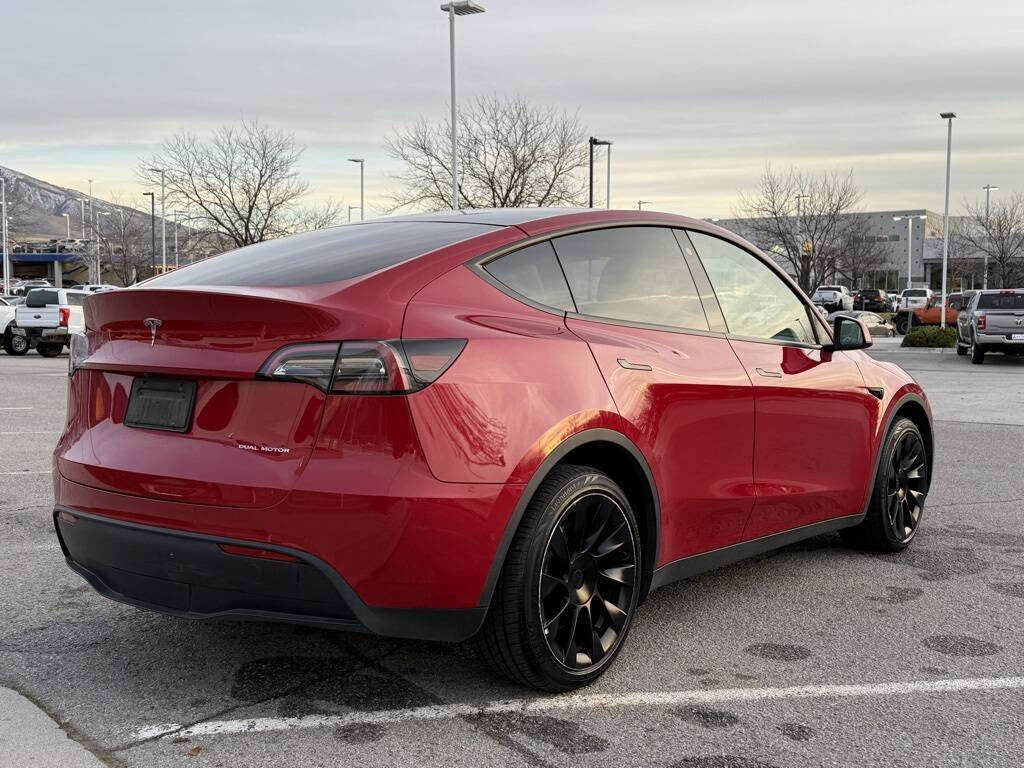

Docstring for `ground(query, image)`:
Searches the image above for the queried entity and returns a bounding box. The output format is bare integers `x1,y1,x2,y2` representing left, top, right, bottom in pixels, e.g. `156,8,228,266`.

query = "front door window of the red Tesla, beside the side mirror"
689,231,816,344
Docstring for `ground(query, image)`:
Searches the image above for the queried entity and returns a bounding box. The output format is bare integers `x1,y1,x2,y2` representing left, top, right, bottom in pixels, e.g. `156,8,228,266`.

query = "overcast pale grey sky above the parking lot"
0,0,1024,216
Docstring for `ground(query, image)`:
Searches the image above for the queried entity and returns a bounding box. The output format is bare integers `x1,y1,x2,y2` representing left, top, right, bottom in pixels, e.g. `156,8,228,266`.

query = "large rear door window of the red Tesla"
553,226,708,331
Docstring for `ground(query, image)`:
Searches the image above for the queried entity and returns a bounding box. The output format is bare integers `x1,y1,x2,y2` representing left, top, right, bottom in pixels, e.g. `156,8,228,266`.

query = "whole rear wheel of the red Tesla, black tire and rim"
476,465,642,692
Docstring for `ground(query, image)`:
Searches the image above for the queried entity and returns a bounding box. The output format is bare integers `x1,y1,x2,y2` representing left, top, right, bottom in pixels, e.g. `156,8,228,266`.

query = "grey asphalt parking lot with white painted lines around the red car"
0,350,1024,768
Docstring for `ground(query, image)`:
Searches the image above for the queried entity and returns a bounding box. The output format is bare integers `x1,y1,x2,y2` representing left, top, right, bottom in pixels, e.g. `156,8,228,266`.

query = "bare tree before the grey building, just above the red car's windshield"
735,165,861,291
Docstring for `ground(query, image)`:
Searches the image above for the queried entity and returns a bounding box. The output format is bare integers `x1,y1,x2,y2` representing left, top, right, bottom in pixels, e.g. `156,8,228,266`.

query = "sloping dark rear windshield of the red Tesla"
145,221,500,288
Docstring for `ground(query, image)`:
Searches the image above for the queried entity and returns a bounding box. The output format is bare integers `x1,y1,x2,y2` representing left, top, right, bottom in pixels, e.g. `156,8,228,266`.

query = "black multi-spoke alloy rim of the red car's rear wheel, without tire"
538,492,637,672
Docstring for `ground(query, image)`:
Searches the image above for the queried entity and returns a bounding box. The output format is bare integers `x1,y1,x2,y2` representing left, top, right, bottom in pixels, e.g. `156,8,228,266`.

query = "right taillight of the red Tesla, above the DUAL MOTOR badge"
257,339,466,394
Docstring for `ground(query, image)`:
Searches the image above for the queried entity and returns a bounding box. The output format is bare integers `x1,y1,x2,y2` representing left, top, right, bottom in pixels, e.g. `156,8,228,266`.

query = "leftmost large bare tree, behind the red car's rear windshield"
137,122,340,247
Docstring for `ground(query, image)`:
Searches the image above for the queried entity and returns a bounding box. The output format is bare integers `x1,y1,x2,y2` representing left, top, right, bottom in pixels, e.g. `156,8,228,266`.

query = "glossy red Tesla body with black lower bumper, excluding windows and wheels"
53,209,932,640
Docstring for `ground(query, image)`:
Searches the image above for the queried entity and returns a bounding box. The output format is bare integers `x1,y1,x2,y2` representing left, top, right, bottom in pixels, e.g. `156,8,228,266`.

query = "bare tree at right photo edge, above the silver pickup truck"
959,194,1024,288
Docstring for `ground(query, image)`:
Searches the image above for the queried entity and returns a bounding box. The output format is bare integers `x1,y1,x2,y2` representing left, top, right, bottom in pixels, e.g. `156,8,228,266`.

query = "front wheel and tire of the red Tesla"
840,418,931,552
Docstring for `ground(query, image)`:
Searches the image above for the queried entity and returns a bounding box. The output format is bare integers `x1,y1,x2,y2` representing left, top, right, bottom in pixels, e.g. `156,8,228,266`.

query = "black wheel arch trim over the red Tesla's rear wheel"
477,428,662,608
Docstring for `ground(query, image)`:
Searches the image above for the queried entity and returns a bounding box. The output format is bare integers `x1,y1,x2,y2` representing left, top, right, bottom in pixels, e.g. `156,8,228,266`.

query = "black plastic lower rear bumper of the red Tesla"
53,506,485,641
